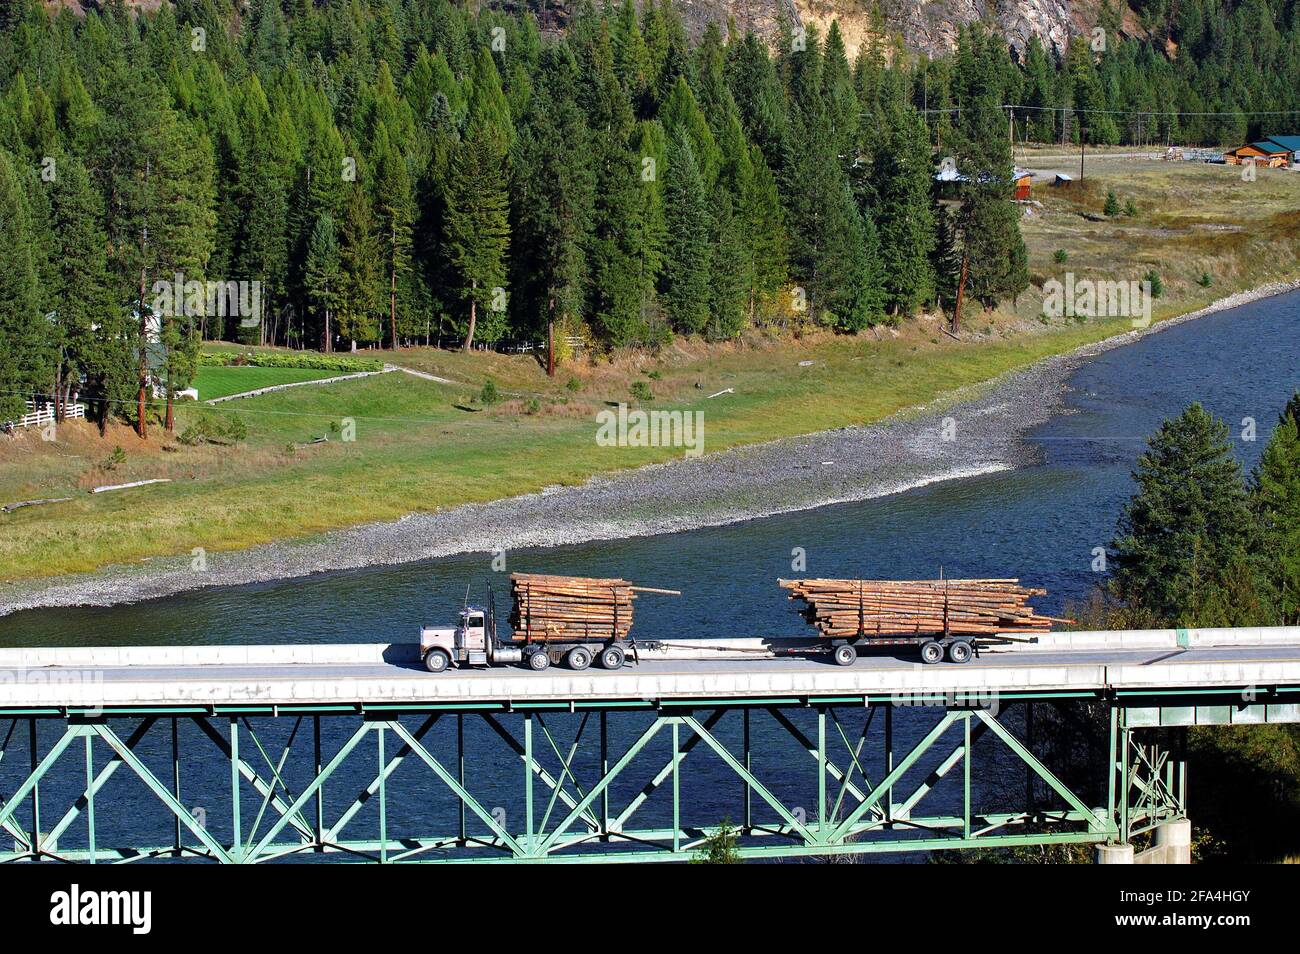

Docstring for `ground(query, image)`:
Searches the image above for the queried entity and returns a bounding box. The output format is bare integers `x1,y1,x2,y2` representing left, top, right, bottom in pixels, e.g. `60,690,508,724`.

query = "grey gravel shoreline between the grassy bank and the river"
0,281,1300,616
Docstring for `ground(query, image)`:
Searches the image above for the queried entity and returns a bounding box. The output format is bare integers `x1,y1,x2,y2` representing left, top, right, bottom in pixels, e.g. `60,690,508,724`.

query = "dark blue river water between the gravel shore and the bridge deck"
0,292,1300,857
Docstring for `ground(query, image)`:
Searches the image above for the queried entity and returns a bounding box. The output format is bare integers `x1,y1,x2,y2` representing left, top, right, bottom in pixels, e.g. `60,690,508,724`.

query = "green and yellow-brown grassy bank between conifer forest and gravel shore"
0,159,1300,580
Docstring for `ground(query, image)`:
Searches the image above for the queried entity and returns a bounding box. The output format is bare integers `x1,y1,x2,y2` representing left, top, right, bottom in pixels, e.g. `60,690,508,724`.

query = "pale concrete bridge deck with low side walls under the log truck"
0,628,1300,711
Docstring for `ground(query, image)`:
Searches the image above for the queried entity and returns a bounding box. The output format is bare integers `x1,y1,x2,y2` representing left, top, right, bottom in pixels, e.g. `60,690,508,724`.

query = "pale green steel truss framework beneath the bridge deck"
0,694,1296,863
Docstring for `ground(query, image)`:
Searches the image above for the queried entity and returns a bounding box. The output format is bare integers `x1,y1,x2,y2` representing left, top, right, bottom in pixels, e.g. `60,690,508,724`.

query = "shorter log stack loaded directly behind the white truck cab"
510,573,675,642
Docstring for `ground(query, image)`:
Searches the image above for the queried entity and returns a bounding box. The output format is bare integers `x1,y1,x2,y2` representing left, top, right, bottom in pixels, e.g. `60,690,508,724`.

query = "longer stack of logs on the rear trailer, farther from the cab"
779,580,1070,638
